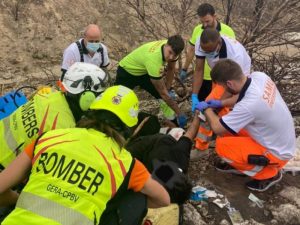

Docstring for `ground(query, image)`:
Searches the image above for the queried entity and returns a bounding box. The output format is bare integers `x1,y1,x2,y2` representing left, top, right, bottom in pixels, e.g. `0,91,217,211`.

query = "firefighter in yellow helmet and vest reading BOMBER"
0,86,170,225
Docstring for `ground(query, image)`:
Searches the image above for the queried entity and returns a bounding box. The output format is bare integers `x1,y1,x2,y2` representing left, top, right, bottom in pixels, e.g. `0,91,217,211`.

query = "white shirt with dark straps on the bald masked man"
61,39,109,70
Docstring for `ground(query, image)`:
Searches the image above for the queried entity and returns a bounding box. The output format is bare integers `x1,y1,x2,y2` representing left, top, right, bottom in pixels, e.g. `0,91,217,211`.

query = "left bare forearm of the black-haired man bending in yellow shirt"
150,79,180,115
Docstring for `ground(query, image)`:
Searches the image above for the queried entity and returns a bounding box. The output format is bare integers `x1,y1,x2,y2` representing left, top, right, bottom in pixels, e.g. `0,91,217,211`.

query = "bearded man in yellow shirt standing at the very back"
179,3,235,101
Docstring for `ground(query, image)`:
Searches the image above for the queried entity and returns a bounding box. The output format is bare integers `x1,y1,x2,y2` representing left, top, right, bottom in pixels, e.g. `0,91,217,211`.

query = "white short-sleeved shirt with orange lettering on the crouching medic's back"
220,72,296,160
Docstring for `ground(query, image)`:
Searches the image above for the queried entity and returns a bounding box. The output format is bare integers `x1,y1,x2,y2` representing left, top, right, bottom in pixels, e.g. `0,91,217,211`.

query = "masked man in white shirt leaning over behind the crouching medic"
191,28,251,159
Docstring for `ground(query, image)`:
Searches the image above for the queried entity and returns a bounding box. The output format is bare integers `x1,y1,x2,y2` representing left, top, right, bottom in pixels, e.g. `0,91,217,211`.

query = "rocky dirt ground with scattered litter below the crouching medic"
184,146,300,225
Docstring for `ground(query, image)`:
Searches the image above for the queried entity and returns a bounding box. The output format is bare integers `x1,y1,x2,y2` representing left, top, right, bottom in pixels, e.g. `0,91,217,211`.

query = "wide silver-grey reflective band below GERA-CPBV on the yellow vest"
17,191,94,225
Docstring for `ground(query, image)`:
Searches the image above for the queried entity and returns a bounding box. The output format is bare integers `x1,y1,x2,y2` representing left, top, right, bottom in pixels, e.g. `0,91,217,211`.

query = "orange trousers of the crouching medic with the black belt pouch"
216,130,288,180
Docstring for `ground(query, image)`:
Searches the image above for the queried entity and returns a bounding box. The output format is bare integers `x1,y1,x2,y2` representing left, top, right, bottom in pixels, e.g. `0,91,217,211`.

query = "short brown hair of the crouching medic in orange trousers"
210,59,243,84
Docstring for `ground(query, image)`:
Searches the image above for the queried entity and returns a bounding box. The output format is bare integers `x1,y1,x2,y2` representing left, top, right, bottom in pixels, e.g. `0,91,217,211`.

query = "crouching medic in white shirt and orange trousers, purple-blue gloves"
196,59,296,192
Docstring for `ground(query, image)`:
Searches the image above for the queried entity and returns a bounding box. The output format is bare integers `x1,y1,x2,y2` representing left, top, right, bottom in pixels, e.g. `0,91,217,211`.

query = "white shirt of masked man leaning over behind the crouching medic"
195,35,251,76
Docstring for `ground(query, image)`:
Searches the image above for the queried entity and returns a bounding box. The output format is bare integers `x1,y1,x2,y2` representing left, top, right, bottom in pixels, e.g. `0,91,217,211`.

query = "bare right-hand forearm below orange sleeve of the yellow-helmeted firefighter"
141,177,171,208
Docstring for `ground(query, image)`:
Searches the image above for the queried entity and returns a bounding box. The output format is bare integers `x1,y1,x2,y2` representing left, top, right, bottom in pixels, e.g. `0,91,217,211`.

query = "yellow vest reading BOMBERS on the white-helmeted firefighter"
0,91,75,167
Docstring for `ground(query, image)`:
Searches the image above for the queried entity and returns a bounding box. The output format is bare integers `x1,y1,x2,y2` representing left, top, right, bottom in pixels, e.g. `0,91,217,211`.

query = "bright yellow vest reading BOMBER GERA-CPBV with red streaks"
11,128,133,224
